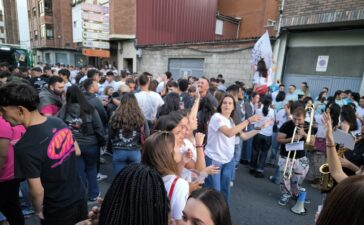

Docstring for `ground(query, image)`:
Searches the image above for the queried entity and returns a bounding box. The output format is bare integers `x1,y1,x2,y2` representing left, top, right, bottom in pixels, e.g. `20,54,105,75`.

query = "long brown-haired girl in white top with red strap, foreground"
142,131,189,225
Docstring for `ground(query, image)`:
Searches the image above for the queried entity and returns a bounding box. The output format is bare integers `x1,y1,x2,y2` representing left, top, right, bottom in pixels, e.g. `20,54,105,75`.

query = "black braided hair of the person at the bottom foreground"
99,164,169,225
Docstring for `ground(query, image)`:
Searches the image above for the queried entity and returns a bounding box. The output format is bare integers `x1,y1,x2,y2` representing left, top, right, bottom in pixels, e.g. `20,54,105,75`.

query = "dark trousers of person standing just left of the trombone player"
250,134,272,173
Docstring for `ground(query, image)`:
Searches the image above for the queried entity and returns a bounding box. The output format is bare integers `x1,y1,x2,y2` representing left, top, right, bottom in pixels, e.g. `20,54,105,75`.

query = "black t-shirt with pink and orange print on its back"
14,117,85,218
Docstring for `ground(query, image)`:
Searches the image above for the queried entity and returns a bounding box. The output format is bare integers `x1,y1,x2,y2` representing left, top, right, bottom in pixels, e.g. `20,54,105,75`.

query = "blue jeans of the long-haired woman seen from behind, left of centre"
112,148,142,176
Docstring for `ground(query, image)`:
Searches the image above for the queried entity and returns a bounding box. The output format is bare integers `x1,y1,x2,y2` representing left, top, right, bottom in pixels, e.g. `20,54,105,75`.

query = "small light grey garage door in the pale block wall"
168,59,204,80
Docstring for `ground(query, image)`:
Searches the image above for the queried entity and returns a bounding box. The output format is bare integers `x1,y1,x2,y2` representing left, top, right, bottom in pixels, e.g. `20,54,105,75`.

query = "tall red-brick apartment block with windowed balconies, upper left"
28,0,82,65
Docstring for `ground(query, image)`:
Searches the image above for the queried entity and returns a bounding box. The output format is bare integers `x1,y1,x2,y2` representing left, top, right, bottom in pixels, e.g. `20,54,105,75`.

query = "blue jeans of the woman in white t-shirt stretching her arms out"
204,156,235,204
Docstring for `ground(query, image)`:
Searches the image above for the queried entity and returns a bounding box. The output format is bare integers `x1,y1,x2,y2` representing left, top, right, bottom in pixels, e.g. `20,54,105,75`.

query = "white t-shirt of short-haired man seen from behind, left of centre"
135,91,164,120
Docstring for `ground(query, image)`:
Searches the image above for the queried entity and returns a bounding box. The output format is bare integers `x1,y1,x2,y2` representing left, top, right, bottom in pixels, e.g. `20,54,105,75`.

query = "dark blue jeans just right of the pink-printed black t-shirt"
77,145,100,199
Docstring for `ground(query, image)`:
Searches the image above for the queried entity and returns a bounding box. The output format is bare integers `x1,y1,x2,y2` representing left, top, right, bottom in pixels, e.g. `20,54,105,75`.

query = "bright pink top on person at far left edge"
0,116,25,182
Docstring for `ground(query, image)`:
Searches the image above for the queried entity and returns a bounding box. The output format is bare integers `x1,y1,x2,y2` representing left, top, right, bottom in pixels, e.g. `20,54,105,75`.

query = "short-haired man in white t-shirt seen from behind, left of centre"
135,74,164,128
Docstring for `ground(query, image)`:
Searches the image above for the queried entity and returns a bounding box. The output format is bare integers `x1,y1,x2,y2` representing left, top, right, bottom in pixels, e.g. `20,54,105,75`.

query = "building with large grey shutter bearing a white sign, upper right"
275,0,364,96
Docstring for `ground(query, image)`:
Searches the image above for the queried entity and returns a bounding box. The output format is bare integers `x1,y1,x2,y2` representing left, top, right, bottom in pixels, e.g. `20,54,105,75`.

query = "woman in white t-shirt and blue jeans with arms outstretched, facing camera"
205,95,260,202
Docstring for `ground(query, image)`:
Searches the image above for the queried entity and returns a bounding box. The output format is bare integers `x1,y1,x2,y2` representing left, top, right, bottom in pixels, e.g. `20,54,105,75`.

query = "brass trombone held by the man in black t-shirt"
283,104,315,180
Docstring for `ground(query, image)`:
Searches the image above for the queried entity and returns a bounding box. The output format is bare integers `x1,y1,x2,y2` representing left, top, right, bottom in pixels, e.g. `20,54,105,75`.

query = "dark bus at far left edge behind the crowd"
0,44,33,67
